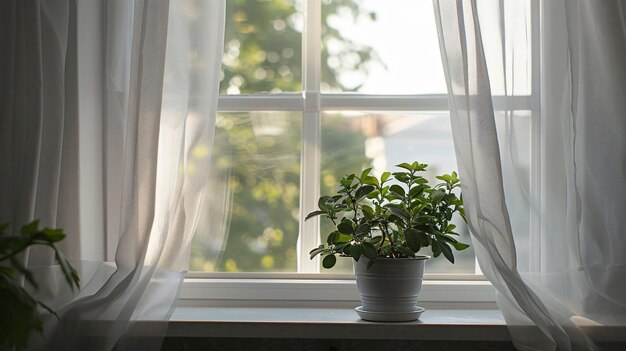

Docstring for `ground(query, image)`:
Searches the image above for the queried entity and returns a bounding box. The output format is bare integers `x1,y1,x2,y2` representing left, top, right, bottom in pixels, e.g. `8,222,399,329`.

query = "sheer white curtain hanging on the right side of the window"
434,0,626,350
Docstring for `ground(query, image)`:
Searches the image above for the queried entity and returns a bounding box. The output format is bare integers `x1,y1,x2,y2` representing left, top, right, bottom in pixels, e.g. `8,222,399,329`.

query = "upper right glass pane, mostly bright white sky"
321,0,446,94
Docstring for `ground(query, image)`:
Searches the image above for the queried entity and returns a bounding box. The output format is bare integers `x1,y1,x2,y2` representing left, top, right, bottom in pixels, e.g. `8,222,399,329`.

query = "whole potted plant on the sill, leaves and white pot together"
305,162,469,321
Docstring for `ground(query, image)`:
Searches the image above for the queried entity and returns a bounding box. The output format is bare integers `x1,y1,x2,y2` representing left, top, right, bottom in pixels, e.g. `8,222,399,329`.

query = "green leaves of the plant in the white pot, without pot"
306,162,469,268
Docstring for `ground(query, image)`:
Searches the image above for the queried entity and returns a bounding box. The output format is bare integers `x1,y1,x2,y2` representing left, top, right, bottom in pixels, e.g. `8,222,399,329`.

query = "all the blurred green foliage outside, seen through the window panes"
190,0,374,272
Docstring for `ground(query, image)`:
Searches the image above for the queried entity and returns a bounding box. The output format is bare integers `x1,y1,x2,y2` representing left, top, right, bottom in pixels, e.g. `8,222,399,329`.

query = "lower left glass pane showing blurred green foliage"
190,112,301,272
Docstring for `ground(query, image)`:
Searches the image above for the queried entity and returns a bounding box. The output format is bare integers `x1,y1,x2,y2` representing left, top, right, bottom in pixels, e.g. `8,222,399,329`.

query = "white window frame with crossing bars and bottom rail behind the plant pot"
180,0,541,308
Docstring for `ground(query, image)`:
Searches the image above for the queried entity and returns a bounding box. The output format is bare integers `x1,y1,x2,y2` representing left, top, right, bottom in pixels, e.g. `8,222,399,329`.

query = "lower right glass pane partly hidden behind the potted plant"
321,112,474,274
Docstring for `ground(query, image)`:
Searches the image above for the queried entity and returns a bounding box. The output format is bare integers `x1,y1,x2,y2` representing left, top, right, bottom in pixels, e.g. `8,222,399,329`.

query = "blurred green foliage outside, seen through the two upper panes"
220,0,378,94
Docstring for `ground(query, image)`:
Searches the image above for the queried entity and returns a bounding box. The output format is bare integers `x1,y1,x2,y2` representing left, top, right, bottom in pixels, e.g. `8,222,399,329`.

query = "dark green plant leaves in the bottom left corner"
0,221,79,350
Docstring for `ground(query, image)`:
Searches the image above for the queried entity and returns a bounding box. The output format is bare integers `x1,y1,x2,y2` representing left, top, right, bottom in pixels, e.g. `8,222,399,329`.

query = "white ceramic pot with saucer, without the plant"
354,256,428,322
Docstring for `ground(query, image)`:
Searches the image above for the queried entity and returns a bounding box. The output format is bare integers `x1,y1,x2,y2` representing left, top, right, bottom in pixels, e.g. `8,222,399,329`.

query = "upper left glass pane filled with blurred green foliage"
220,0,303,94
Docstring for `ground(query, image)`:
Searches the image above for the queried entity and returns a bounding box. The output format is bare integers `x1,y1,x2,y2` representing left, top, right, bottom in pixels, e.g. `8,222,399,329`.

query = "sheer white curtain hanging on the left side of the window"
0,0,225,350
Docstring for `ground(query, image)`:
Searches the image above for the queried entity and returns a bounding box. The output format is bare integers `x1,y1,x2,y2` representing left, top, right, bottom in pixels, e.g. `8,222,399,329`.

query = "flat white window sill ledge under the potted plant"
167,307,510,341
